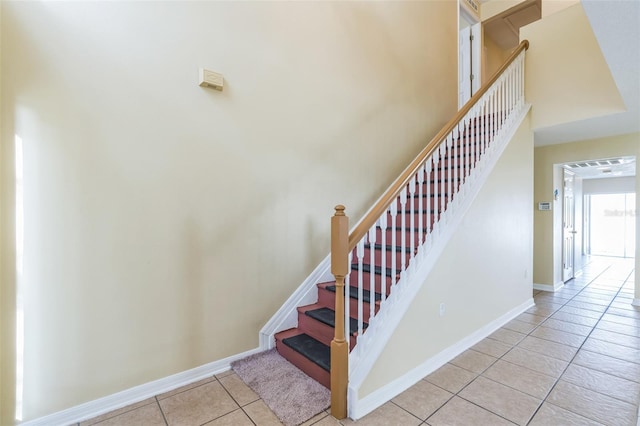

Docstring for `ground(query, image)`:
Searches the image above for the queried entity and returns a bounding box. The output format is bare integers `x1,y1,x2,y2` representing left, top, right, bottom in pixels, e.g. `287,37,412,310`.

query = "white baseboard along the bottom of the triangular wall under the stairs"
349,298,535,420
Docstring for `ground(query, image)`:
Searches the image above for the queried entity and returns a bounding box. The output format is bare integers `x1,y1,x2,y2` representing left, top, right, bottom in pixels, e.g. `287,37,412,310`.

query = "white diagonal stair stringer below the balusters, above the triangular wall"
347,103,531,419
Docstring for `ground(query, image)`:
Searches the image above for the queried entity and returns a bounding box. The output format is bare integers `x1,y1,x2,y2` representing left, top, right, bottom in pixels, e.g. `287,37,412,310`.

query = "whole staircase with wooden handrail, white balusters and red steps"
260,41,529,418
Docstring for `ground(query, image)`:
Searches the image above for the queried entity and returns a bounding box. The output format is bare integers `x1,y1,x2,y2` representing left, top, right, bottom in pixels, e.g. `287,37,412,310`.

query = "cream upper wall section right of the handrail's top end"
520,4,625,130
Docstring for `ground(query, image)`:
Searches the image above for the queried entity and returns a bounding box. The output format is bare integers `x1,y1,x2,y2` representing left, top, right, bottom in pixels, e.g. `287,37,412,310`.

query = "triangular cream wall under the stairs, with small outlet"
360,112,533,397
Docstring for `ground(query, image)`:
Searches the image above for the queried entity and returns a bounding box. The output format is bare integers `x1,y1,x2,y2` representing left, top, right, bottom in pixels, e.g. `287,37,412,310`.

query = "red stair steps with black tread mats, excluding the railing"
275,117,495,388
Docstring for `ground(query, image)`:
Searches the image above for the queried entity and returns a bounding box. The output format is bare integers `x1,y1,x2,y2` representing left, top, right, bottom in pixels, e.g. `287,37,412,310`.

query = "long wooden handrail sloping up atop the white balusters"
348,40,529,251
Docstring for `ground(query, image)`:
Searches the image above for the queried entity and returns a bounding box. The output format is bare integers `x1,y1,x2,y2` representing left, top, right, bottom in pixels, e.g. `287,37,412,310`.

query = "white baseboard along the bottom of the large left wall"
20,348,262,426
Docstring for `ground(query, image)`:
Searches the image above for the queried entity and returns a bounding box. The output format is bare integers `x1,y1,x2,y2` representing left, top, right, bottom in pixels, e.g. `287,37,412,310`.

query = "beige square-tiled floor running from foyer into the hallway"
80,258,640,426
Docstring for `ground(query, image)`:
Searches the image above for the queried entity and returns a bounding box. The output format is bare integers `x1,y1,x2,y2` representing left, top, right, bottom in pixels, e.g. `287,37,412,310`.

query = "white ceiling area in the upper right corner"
535,0,640,146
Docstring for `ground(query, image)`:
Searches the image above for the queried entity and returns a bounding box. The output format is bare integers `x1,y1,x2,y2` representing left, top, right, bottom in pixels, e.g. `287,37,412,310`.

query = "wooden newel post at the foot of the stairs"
331,205,349,419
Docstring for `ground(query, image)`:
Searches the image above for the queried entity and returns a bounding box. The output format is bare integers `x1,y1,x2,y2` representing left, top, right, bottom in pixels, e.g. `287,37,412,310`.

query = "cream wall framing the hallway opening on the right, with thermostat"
533,133,640,291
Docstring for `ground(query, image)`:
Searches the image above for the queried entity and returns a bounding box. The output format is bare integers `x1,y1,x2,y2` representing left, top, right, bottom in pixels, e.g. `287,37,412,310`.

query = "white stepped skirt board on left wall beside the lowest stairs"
260,255,334,350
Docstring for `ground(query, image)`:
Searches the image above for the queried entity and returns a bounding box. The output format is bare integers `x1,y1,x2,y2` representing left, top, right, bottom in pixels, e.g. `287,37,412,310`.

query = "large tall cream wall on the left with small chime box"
0,1,457,419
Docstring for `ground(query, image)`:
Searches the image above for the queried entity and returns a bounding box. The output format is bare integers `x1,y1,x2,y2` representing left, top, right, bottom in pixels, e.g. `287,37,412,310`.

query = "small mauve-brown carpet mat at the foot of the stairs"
231,349,331,426
